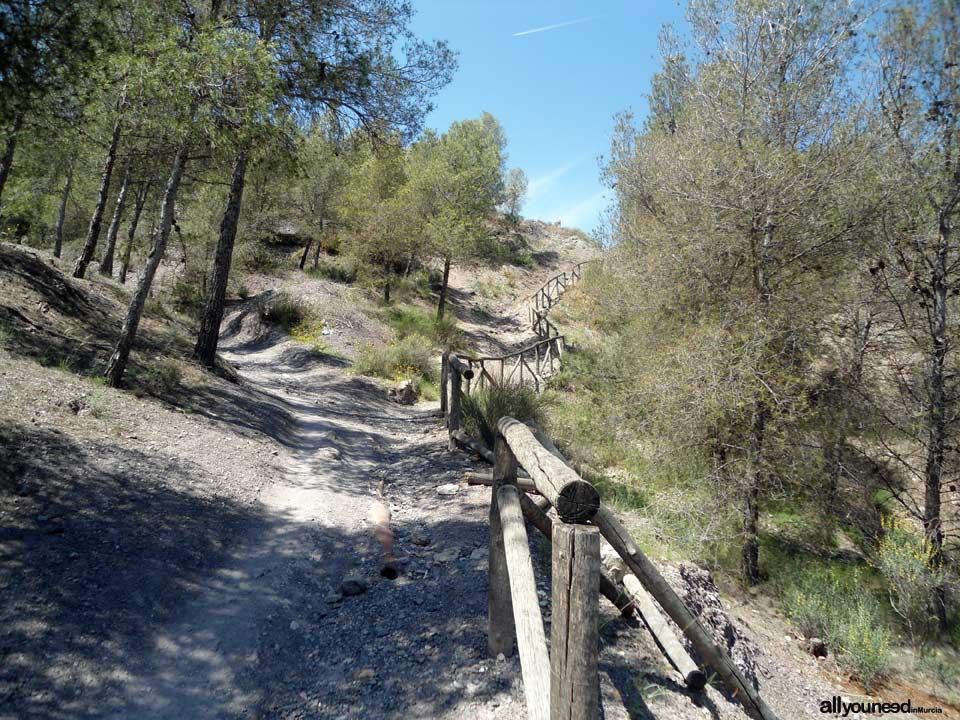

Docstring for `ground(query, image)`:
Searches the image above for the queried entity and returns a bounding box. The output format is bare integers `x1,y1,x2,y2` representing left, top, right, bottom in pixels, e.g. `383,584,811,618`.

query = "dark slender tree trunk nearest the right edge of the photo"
923,218,950,627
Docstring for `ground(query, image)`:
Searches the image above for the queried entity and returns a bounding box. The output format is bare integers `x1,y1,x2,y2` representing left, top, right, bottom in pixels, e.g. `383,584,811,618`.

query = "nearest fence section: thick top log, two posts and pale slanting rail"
487,418,600,720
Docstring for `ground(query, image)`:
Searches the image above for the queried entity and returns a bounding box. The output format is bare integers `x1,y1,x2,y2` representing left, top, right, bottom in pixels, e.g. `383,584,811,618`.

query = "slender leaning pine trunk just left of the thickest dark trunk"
103,143,187,387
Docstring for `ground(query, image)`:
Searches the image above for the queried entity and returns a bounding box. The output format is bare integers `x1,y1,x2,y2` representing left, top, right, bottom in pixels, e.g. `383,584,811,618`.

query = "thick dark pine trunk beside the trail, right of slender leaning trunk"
193,151,248,368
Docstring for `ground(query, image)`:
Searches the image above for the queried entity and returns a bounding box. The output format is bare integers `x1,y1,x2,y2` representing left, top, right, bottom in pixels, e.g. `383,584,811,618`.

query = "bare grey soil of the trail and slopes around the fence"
0,239,947,720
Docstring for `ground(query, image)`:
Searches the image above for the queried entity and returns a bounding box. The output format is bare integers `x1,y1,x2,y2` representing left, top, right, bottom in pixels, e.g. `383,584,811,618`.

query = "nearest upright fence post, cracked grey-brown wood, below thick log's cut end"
550,523,600,720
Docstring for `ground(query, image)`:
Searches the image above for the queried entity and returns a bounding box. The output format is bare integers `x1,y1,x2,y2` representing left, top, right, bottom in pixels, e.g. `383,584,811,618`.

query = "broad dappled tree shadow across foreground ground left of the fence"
0,425,518,720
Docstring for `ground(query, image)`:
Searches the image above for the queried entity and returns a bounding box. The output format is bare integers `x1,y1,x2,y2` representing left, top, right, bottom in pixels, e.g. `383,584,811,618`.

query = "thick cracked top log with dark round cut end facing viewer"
497,417,600,523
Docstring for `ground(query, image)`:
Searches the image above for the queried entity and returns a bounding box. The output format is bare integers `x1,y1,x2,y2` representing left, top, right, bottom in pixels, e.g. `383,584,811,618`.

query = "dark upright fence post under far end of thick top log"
487,433,517,657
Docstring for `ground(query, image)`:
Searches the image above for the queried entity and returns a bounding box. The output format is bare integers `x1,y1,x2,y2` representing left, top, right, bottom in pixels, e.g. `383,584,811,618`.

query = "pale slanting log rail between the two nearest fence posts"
491,484,552,720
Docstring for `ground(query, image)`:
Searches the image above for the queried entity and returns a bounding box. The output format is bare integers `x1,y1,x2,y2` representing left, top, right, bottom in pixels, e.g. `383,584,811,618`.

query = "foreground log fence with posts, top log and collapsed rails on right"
442,374,776,720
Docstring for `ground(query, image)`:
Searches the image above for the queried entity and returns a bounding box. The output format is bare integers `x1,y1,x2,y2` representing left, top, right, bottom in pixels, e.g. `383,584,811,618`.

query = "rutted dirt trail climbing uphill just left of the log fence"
110,288,560,720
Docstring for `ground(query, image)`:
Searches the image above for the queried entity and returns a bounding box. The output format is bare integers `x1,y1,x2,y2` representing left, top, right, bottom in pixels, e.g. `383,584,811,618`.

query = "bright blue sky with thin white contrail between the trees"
414,0,683,231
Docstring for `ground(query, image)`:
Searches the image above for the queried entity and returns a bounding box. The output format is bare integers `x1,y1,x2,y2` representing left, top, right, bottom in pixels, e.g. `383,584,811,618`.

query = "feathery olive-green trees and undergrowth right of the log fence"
540,1,960,686
